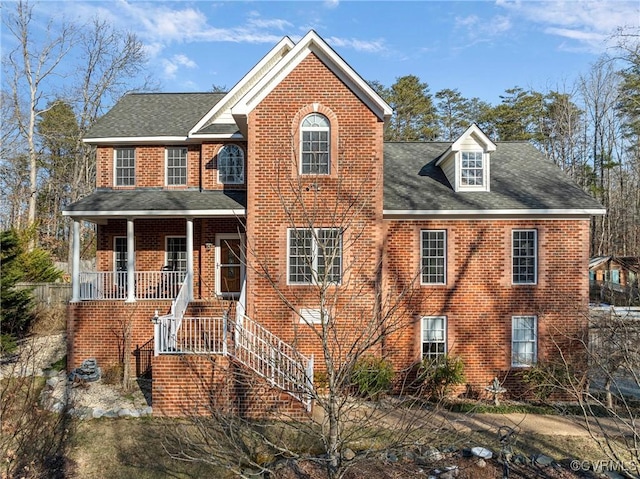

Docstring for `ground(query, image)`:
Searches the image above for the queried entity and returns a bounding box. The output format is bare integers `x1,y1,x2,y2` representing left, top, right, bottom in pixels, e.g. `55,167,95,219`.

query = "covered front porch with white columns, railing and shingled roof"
64,190,245,302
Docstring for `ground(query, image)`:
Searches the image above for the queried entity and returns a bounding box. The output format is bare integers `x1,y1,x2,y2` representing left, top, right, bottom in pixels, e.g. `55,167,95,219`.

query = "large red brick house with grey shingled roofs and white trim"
64,31,604,415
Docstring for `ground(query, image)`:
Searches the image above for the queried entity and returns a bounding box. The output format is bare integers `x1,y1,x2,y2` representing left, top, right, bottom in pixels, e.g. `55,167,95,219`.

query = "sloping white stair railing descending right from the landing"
231,314,313,411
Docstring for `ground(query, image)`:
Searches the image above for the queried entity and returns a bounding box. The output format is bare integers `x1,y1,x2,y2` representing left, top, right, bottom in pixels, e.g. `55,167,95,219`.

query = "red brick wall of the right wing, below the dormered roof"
385,220,589,398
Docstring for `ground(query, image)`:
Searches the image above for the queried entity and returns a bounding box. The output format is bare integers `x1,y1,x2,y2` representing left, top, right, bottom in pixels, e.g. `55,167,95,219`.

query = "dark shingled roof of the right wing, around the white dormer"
384,142,604,218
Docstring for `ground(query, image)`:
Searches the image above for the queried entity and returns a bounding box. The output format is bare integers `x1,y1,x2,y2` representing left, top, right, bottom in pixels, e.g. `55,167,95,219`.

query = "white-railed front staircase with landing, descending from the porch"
153,280,313,411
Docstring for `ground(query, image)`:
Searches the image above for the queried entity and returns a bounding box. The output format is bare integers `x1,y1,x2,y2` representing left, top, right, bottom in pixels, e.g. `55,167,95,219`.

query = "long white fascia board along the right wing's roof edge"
382,208,607,220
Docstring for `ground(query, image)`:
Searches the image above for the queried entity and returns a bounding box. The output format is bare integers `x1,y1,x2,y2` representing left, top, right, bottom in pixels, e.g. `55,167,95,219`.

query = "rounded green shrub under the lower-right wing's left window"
417,354,465,400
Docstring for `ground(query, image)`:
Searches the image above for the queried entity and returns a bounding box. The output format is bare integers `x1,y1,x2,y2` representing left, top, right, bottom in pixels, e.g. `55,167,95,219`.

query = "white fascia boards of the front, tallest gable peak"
231,30,393,124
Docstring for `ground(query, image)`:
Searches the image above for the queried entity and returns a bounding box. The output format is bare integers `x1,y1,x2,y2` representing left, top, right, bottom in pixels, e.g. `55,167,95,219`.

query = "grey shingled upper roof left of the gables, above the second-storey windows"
85,93,226,143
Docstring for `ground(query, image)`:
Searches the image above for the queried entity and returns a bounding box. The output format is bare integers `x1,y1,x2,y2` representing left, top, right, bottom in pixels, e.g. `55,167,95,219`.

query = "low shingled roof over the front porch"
63,189,247,219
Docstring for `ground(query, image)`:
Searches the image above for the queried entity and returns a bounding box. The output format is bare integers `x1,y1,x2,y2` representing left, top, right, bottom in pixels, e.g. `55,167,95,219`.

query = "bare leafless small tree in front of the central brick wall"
160,144,452,478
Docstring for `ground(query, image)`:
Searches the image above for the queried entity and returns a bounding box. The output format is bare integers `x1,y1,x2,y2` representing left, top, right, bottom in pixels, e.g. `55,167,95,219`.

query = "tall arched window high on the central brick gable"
300,113,331,175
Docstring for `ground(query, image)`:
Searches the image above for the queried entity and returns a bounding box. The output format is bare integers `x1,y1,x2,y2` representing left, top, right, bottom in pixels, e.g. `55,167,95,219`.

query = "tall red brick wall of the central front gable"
247,54,383,368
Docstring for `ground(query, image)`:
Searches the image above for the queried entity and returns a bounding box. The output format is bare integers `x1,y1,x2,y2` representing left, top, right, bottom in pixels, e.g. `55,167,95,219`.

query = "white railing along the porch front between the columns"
79,271,186,301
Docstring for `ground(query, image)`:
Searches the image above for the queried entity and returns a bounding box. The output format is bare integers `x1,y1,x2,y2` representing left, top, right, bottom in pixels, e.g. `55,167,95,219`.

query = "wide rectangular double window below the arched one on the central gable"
287,228,342,284
